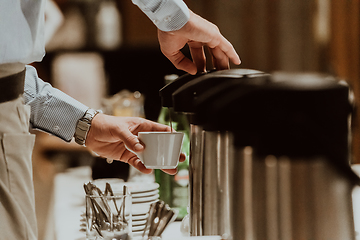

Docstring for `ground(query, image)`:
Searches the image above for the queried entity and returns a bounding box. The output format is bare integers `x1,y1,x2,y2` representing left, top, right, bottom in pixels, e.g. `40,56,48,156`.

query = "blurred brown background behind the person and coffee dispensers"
33,0,360,239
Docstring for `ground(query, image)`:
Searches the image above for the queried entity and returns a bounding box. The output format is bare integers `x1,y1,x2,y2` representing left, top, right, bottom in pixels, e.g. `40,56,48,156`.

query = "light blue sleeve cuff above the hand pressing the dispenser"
132,0,190,32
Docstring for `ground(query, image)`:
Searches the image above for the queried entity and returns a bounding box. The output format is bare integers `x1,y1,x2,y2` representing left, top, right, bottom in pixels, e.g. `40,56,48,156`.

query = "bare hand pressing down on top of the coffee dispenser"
158,11,241,74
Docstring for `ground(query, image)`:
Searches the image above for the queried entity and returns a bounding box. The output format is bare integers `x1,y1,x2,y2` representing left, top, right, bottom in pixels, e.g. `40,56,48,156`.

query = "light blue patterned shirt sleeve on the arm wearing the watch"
24,66,89,142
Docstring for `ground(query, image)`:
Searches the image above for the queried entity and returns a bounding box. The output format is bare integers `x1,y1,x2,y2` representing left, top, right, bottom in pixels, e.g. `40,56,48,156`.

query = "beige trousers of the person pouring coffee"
0,97,37,240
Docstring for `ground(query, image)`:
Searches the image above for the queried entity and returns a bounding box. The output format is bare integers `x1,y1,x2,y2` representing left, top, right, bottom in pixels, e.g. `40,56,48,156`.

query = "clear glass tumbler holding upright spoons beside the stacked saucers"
86,193,132,240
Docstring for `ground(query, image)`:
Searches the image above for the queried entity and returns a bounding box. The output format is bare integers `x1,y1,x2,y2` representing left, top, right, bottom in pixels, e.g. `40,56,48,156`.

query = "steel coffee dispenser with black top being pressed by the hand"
160,69,267,236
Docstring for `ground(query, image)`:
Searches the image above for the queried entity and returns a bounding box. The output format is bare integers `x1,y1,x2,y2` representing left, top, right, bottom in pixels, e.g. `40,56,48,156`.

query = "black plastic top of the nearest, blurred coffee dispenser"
195,73,358,181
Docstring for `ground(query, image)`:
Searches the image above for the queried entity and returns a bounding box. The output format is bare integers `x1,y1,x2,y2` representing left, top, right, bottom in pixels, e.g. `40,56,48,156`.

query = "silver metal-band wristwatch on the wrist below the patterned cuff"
74,108,99,146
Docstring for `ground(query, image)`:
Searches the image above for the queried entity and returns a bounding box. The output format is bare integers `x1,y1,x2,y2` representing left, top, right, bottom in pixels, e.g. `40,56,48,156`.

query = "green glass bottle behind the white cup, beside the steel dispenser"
155,75,190,220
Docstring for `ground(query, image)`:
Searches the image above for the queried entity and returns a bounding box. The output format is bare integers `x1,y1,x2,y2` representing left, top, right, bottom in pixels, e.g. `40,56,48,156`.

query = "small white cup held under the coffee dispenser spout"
135,132,184,169
